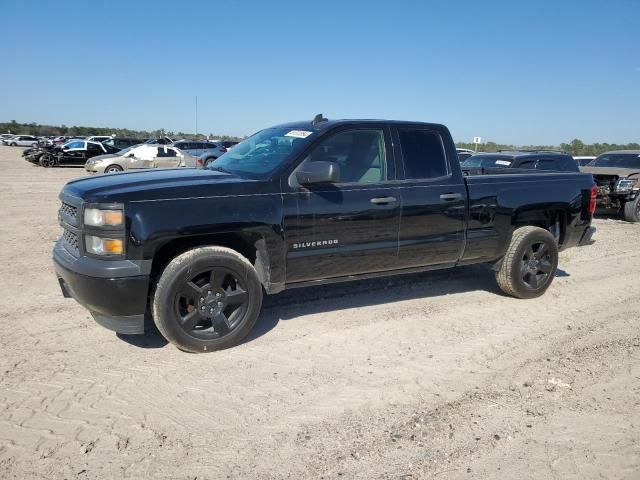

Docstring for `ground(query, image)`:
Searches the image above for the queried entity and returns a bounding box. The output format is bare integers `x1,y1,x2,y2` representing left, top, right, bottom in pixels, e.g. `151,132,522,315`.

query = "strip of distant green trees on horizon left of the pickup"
0,120,240,141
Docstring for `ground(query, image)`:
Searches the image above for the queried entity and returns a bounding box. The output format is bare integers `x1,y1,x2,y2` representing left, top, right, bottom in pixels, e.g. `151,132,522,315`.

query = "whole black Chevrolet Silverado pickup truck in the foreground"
53,116,596,352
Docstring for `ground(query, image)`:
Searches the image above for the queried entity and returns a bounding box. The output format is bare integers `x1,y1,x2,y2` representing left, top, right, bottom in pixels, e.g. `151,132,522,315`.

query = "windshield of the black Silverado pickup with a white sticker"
207,128,315,179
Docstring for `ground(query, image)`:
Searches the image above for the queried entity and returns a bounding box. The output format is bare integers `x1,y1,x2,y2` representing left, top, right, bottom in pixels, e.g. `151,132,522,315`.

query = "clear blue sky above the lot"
0,0,640,145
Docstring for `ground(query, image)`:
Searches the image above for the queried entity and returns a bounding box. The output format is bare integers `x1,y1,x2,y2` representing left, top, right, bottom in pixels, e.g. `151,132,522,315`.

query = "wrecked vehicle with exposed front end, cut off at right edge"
580,150,640,222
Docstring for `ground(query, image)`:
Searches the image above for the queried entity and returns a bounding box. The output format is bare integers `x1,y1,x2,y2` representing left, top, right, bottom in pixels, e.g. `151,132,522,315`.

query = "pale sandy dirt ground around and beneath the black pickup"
0,147,640,480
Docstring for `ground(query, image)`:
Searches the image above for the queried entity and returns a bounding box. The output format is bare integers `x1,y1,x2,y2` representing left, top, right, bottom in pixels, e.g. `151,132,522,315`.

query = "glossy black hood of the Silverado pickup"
63,168,264,203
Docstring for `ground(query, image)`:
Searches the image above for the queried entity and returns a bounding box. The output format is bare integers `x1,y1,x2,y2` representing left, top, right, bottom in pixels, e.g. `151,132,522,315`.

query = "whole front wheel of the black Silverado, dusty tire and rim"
153,247,262,353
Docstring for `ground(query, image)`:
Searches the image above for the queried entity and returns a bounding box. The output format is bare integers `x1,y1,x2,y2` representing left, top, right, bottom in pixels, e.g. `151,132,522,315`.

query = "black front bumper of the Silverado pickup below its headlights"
53,241,150,334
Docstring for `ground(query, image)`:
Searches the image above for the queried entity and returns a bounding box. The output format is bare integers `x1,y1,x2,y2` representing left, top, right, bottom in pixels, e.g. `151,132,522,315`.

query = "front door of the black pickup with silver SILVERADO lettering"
284,124,400,283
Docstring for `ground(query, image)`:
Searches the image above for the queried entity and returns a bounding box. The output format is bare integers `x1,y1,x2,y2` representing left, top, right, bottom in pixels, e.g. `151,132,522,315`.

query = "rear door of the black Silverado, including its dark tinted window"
394,126,466,268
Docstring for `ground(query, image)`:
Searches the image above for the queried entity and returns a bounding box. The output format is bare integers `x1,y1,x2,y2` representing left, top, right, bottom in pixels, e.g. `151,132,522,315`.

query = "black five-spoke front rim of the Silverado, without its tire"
174,267,249,340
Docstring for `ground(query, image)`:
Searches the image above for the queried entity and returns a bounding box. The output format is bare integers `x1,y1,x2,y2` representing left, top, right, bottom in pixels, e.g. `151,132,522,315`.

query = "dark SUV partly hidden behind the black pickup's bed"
461,150,579,172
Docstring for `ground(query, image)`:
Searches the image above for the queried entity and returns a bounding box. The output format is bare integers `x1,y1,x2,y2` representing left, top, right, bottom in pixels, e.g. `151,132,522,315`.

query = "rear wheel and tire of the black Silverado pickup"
496,227,558,298
